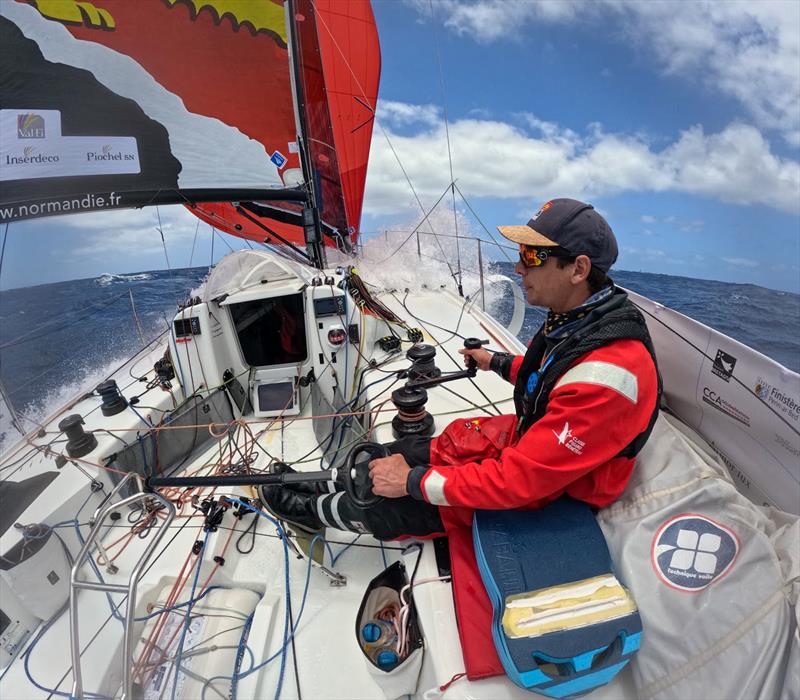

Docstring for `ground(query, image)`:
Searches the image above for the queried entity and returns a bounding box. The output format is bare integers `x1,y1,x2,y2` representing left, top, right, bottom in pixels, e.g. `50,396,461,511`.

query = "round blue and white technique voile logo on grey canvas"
651,513,739,593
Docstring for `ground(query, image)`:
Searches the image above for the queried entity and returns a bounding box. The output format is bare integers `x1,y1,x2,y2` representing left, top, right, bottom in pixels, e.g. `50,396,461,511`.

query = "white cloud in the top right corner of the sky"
410,0,800,146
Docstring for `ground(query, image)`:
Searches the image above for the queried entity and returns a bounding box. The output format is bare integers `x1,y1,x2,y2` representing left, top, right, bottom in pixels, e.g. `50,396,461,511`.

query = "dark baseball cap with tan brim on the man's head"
497,199,618,272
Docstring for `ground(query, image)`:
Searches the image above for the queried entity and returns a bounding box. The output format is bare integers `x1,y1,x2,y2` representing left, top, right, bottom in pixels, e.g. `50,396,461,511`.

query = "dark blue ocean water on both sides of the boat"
0,263,800,452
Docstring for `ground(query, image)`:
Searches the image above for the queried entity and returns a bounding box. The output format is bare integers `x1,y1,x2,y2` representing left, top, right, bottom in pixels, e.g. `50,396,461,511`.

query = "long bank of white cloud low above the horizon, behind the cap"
365,105,800,215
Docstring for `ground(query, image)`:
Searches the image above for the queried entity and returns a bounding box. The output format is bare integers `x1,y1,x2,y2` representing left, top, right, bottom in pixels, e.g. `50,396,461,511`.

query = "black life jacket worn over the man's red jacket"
514,289,662,457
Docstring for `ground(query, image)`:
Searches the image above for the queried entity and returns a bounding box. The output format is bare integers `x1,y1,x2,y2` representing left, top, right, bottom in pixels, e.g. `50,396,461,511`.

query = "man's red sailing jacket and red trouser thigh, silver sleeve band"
408,290,659,529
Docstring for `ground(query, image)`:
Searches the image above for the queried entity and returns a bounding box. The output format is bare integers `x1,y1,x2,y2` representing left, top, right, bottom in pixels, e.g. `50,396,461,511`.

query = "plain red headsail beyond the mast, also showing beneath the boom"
190,0,380,246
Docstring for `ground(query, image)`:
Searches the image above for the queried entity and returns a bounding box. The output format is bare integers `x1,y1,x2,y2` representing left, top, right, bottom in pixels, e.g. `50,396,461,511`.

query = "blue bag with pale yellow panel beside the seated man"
472,497,642,698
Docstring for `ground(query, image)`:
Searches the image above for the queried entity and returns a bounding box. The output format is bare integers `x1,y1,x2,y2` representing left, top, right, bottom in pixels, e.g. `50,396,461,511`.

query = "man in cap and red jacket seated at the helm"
262,199,661,539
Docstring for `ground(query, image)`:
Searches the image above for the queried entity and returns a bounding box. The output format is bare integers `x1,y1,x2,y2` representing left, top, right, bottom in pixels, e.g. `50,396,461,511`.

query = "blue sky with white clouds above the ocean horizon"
0,0,800,292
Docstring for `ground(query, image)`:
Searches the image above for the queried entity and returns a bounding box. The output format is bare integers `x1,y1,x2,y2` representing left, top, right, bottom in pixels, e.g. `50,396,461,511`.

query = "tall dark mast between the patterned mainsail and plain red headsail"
286,0,327,270
